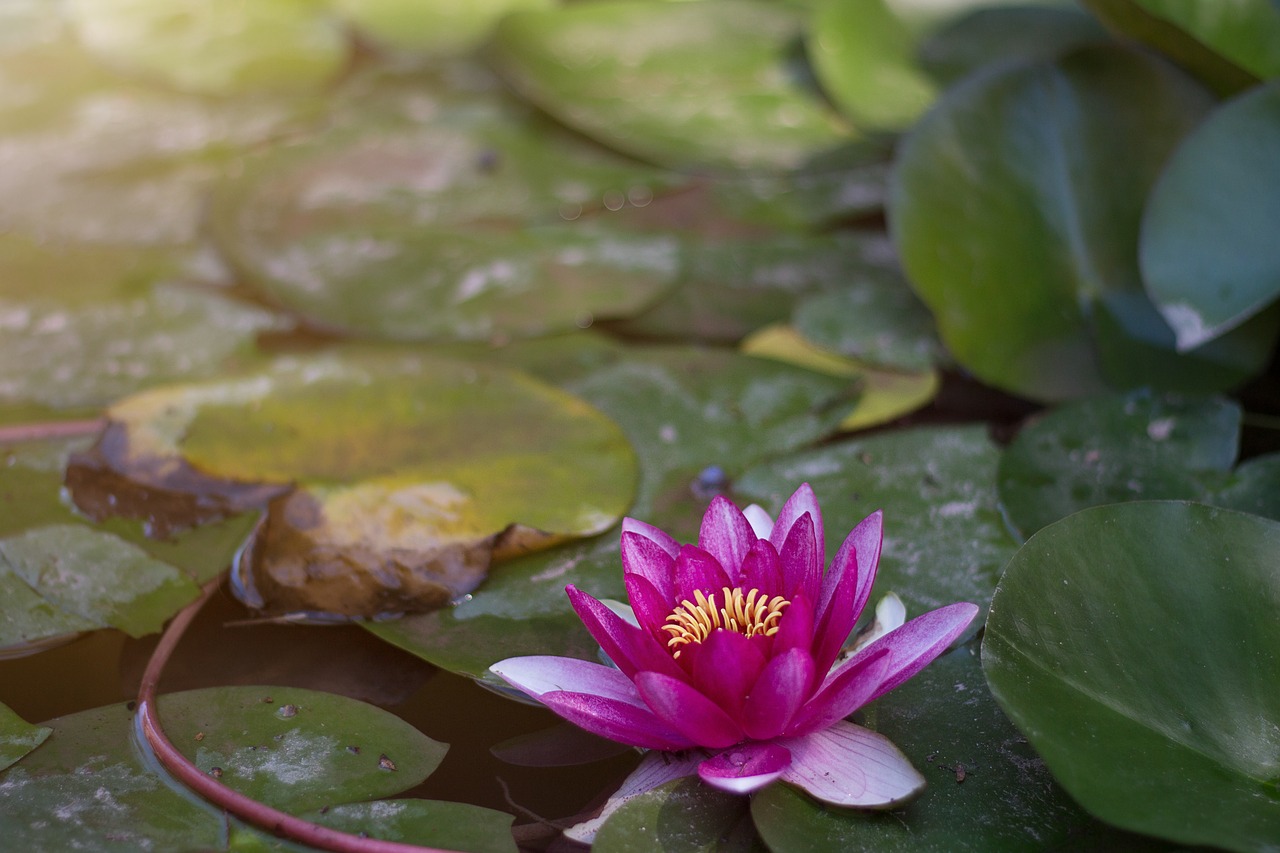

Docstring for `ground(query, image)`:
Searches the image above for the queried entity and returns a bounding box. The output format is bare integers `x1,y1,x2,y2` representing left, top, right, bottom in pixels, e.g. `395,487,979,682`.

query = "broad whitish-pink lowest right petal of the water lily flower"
778,722,924,808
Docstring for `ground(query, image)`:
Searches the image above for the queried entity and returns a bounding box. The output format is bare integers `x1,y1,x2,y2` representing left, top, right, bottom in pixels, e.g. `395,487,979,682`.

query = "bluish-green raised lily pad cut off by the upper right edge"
1140,79,1280,350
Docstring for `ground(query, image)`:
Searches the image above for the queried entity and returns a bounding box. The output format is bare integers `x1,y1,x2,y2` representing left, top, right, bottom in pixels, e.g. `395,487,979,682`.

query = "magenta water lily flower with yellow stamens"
493,485,978,829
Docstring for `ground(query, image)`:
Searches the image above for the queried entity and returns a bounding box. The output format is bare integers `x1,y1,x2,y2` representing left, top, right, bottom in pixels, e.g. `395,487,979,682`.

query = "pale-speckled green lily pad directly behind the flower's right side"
733,427,1016,625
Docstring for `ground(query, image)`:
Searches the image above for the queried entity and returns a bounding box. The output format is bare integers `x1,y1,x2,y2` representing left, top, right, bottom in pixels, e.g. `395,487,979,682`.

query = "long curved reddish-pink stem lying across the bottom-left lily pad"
138,578,456,853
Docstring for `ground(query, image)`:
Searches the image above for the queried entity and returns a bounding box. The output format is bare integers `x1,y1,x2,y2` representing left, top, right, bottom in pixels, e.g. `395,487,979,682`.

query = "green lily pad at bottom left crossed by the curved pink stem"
0,686,447,850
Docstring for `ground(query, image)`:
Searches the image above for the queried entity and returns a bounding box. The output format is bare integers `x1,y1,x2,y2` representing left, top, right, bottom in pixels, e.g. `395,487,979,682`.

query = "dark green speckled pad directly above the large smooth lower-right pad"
1000,393,1280,538
